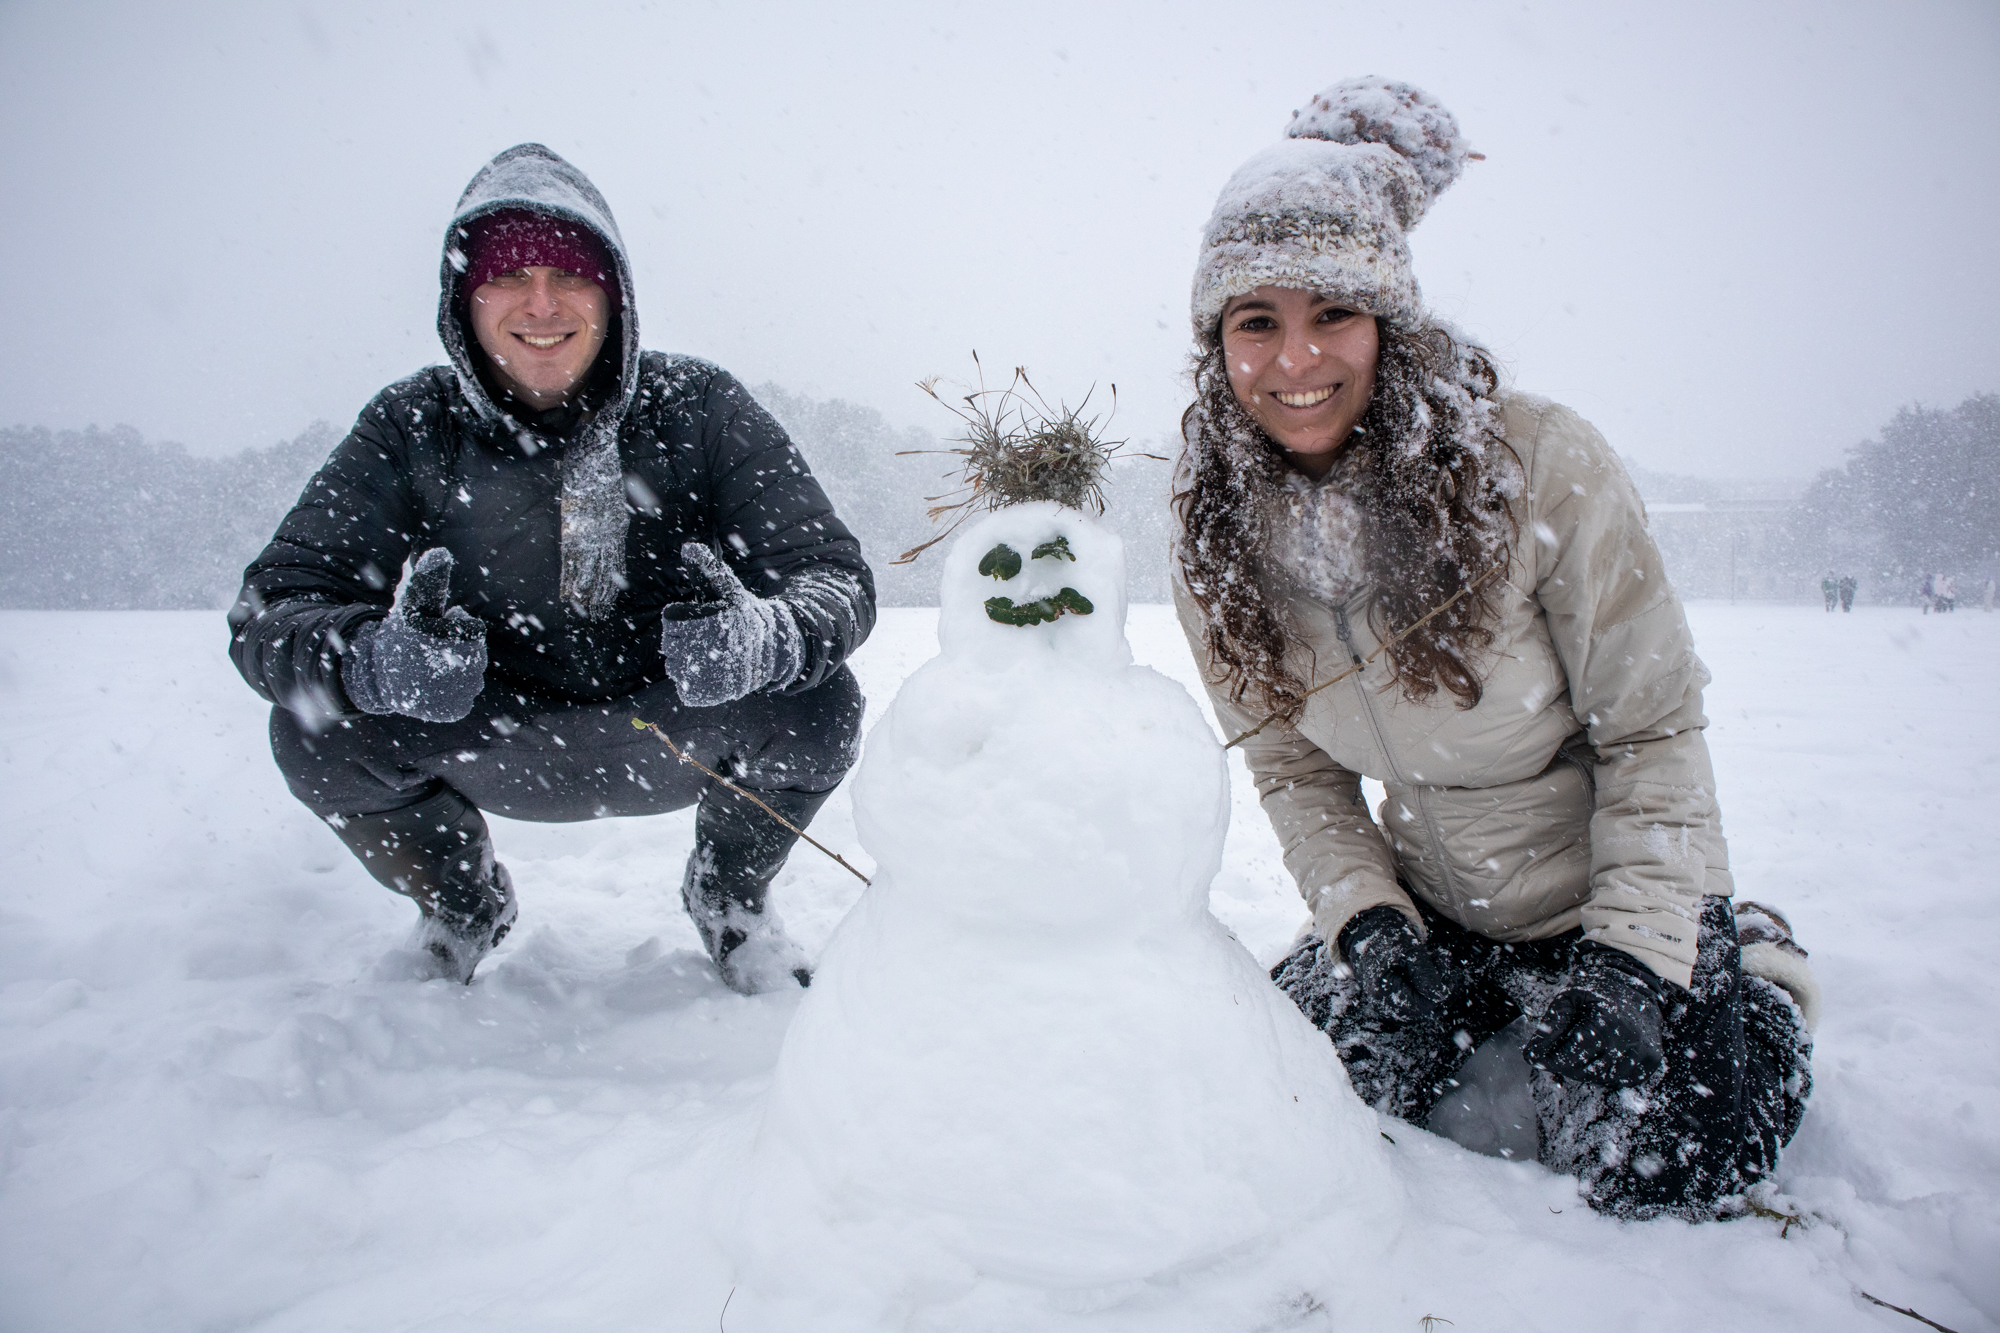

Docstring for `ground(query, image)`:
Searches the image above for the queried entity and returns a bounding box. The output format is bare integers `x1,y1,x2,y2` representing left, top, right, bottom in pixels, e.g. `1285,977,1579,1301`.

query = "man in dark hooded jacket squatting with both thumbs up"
230,144,874,993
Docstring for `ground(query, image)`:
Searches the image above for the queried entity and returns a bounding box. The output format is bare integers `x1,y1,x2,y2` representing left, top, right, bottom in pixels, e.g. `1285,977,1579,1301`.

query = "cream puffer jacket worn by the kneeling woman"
1174,394,1732,985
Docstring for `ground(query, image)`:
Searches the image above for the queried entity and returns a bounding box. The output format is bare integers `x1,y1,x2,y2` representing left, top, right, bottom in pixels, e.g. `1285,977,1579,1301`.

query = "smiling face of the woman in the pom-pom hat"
1222,286,1382,476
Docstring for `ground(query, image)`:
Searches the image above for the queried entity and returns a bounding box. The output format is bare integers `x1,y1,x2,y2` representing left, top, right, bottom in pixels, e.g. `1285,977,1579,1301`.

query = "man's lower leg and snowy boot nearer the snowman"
680,787,832,995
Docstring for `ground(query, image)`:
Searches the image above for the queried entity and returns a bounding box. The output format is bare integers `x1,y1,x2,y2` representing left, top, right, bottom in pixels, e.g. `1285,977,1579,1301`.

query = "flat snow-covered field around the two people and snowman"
0,604,2000,1333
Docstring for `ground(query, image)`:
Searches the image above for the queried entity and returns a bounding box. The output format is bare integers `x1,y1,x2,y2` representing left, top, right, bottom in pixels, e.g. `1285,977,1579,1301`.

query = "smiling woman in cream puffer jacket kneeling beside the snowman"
1174,80,1818,1219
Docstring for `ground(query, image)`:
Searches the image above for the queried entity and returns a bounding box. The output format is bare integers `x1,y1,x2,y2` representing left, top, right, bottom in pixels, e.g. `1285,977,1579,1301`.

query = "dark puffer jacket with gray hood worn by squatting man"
230,144,874,719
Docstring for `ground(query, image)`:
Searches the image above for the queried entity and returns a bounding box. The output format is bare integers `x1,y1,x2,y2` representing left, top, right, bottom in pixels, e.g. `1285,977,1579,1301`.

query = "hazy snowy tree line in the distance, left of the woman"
0,384,1168,610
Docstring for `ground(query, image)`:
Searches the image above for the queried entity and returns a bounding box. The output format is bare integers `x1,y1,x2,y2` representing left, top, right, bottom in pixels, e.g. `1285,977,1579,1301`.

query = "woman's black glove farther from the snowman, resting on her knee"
1528,939,1680,1087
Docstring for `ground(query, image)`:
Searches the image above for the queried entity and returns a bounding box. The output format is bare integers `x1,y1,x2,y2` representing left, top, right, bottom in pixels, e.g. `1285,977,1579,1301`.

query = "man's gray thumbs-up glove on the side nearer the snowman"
660,542,806,709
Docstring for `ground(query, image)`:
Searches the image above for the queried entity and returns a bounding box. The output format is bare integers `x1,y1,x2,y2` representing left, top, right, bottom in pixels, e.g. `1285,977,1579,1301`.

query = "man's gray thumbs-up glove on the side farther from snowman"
340,546,486,723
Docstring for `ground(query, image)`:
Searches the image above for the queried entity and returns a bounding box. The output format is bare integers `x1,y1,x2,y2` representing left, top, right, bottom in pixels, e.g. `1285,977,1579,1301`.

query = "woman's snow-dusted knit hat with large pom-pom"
1194,76,1480,338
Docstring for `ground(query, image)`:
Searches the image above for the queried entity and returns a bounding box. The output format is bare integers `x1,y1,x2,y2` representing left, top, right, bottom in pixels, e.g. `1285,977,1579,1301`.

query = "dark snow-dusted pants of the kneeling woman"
1272,899,1812,1219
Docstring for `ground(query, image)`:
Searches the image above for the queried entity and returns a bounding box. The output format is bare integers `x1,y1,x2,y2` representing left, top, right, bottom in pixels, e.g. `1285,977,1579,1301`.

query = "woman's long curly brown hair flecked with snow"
1174,320,1520,721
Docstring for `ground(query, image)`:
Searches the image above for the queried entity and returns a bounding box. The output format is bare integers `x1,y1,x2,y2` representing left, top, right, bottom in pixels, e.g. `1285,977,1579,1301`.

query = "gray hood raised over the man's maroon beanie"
438,144,638,436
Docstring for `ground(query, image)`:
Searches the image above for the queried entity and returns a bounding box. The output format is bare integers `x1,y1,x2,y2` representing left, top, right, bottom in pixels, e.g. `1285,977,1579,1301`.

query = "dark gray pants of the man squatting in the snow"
270,667,862,939
